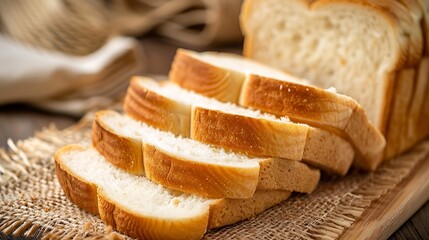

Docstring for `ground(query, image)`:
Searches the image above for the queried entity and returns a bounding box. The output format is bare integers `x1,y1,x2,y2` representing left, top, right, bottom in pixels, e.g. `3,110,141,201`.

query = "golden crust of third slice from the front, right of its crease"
191,103,354,175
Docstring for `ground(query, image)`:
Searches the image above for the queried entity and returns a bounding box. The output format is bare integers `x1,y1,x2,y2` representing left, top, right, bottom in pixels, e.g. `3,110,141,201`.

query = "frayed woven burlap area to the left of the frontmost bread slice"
0,113,128,239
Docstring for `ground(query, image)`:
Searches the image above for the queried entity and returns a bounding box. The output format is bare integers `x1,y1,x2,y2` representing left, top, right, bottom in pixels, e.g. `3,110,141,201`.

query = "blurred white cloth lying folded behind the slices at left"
0,36,144,115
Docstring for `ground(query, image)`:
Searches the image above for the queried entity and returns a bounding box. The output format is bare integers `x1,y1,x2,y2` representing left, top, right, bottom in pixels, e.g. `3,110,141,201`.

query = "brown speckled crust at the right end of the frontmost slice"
208,190,291,229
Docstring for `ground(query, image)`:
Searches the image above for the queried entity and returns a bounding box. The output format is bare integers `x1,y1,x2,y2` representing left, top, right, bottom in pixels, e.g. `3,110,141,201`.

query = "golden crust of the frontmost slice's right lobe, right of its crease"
98,190,209,240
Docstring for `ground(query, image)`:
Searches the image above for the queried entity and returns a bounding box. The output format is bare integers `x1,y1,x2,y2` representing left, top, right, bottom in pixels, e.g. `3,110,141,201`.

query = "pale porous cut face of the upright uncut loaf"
241,0,406,127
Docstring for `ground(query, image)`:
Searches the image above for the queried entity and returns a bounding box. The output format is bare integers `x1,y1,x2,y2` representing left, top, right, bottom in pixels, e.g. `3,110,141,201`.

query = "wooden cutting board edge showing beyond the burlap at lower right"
339,153,429,240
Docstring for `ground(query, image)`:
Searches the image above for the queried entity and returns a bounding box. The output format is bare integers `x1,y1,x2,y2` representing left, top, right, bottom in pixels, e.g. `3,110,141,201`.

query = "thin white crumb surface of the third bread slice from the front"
138,77,290,123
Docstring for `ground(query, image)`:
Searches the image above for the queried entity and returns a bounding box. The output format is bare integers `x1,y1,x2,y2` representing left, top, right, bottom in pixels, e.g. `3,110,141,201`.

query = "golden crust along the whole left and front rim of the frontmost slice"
54,145,209,239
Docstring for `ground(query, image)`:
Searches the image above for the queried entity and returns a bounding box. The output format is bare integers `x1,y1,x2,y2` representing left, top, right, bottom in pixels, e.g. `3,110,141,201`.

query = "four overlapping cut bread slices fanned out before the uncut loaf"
55,50,385,239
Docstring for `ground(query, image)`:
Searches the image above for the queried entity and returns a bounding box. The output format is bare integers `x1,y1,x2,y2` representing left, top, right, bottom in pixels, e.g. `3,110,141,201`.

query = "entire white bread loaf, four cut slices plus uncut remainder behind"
54,0,429,239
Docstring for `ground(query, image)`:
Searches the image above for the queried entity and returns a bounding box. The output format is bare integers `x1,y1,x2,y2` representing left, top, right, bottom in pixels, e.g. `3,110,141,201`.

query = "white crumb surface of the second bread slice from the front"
99,111,259,168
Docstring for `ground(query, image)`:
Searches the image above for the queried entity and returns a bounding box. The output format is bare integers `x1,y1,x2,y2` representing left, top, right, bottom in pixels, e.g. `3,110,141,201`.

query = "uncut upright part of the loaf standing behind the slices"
241,0,429,158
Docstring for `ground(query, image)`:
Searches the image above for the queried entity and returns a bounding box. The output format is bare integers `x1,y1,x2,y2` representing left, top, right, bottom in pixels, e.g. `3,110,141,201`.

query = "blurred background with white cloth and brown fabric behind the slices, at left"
0,0,242,146
